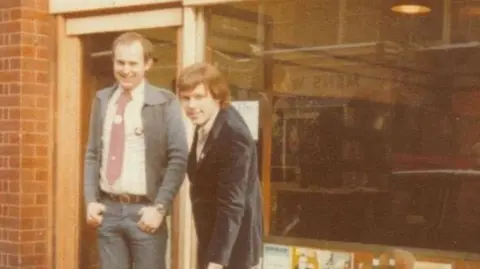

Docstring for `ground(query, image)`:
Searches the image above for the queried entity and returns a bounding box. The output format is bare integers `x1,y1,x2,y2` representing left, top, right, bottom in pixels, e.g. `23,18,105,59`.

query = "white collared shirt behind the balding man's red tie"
100,81,147,195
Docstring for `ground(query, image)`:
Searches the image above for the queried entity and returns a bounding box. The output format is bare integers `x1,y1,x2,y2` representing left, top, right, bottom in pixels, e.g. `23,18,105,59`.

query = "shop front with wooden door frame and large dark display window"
50,0,480,269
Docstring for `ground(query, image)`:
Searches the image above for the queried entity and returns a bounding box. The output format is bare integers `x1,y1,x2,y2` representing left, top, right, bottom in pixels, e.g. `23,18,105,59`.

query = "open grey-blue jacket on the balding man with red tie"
84,83,188,209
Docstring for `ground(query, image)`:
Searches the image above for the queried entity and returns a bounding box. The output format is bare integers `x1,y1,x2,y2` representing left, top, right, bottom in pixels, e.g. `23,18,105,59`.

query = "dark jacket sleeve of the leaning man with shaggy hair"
208,131,252,266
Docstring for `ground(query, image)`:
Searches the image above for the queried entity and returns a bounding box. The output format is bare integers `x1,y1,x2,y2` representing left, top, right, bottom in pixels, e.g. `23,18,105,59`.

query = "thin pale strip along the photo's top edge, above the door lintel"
49,0,181,14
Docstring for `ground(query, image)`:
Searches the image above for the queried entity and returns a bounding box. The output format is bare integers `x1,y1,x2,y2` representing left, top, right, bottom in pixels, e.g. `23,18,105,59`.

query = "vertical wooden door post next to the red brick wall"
55,17,83,269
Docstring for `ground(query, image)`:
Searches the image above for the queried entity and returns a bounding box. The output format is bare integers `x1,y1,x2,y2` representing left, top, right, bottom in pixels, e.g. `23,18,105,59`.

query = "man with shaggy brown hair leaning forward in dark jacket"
177,63,263,269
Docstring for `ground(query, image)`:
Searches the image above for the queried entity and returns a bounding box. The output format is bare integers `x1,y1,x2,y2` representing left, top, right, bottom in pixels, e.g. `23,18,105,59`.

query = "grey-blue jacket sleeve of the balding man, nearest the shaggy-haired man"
155,98,188,210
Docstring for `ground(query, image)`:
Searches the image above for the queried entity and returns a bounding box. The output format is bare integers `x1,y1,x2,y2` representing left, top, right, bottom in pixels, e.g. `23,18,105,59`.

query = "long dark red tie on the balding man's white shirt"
106,91,132,185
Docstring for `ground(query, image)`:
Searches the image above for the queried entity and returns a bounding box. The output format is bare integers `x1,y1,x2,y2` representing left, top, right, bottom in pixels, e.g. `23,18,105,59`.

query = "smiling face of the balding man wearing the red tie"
113,41,152,90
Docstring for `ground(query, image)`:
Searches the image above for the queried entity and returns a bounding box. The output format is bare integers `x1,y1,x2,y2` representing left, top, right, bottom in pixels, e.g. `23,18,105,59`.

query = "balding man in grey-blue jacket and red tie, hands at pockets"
84,32,188,269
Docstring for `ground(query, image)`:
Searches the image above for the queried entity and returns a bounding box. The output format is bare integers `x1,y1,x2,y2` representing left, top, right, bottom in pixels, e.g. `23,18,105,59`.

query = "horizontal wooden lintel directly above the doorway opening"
66,8,182,35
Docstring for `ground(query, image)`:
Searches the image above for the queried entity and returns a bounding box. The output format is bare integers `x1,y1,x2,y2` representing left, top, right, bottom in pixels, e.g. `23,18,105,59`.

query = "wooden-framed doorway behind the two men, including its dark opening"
53,7,201,269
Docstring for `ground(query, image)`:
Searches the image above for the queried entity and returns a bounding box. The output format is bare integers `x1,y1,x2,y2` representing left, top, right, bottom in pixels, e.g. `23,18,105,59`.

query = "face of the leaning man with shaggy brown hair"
180,84,220,126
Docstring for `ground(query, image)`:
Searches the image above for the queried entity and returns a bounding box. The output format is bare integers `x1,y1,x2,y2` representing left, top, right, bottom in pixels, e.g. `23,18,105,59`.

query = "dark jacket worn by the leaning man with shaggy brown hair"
188,106,263,269
